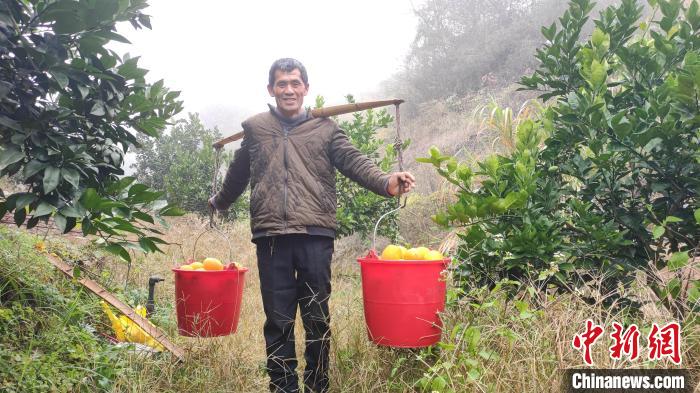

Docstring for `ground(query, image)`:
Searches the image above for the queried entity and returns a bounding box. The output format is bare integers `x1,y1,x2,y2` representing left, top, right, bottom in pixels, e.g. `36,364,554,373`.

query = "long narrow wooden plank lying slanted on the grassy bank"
46,254,185,361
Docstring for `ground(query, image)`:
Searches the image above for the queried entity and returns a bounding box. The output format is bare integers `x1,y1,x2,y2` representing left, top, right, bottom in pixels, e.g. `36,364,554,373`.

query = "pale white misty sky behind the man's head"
115,0,423,133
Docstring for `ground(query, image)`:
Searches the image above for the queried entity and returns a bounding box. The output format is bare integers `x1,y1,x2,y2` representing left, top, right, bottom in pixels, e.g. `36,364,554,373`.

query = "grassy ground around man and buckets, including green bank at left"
0,210,700,392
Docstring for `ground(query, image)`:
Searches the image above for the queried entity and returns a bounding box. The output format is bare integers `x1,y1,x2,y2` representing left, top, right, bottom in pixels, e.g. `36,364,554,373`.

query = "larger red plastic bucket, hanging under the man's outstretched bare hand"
357,257,450,348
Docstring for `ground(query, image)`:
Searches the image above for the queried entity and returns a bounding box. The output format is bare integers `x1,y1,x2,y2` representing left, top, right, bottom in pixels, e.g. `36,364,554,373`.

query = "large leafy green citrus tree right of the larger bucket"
422,0,700,318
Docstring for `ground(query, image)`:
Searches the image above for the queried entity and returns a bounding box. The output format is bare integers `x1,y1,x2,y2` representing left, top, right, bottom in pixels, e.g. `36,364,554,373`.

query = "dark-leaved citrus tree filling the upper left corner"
0,0,182,260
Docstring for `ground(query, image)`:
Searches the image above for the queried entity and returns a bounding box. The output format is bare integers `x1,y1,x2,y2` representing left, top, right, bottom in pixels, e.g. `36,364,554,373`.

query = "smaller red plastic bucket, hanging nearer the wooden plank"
172,268,248,337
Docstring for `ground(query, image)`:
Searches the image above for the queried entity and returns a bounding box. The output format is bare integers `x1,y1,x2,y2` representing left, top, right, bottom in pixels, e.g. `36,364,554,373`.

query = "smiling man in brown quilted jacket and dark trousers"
209,59,414,393
